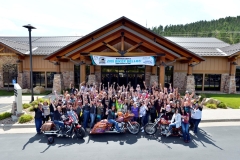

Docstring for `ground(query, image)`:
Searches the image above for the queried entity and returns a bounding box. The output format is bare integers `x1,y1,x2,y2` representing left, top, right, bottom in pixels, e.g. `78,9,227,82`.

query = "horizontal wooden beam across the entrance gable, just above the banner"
90,52,156,57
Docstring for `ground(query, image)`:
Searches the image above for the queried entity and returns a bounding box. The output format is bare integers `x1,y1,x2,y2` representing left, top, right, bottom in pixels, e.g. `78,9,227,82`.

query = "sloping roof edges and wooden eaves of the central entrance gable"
45,17,204,61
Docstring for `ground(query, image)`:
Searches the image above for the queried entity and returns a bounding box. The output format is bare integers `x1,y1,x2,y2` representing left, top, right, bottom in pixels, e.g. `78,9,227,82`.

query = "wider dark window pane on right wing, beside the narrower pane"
204,74,221,91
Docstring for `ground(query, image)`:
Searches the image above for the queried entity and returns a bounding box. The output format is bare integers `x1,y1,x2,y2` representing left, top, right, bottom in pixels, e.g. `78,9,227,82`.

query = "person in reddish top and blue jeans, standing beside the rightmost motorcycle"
181,108,190,143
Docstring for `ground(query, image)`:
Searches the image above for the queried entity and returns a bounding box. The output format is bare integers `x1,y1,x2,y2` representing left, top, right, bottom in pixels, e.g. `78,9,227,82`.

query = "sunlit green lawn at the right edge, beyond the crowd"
206,94,240,109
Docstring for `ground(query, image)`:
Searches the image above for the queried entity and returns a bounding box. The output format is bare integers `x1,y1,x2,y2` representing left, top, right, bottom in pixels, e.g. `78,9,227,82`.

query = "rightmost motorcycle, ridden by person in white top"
144,116,182,136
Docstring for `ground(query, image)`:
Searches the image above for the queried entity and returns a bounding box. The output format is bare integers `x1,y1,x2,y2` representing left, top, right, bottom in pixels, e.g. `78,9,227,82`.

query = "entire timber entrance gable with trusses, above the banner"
45,17,204,65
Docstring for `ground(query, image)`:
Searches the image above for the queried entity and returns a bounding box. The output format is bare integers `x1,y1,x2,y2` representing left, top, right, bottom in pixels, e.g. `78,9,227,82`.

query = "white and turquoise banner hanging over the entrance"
91,55,155,66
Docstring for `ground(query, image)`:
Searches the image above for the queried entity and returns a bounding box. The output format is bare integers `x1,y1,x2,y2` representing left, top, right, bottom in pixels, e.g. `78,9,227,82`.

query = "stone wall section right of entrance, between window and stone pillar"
173,72,187,91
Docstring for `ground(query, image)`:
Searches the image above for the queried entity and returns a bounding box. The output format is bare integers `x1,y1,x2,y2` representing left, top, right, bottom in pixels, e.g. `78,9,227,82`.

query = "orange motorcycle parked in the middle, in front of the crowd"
90,113,140,134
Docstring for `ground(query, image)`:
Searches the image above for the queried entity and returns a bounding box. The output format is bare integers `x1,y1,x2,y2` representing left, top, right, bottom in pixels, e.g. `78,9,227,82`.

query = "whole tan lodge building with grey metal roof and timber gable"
0,17,240,93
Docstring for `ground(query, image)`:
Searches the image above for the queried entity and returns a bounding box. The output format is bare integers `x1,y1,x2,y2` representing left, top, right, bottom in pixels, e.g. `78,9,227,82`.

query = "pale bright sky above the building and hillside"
0,0,240,36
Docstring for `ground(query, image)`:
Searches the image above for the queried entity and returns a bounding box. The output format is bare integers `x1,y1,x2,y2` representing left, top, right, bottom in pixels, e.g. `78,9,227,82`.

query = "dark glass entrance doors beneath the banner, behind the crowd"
101,66,145,88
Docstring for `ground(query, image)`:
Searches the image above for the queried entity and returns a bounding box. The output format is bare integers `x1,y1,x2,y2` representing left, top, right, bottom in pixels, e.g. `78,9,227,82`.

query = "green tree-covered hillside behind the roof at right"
149,16,240,44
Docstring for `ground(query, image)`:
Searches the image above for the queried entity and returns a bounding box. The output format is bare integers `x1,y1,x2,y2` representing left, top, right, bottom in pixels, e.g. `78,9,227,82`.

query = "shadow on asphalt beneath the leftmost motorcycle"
22,134,85,153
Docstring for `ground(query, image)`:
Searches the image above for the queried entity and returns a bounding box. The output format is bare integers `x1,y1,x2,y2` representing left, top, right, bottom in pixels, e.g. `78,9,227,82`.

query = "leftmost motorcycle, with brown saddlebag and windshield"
41,111,85,139
